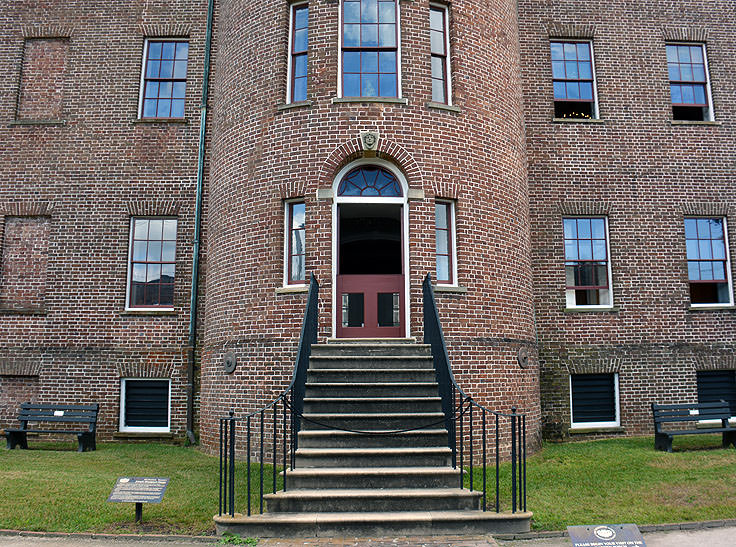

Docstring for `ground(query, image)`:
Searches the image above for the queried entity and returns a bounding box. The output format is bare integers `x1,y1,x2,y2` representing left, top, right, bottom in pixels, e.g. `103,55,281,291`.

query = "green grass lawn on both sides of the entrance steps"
0,436,736,534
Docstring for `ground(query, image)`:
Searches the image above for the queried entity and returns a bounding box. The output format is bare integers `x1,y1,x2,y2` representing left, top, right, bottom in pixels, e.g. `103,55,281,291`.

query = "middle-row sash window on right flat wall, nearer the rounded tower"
562,217,613,308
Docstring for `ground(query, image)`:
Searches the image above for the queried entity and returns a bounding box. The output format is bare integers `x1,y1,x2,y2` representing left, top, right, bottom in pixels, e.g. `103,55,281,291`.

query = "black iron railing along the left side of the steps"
214,274,319,516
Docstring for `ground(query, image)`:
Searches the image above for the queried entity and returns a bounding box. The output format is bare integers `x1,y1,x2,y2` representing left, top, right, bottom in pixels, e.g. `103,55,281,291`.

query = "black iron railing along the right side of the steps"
422,274,526,513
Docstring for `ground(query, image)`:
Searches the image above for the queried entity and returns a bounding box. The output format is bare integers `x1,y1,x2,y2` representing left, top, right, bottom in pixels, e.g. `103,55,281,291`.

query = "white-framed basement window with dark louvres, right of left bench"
120,378,171,433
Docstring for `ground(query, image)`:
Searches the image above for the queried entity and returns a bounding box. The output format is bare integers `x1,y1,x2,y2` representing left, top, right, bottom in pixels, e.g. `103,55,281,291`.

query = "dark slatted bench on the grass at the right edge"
652,401,736,452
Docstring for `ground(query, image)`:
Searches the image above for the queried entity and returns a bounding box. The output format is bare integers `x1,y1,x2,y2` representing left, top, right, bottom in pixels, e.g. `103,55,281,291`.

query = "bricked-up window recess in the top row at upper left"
18,38,69,120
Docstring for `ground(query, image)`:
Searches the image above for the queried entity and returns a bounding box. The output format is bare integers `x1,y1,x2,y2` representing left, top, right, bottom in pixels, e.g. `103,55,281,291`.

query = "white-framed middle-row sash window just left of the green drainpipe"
125,217,176,310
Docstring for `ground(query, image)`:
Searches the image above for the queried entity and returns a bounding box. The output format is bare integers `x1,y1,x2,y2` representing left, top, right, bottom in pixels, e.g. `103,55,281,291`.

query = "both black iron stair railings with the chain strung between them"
219,275,526,516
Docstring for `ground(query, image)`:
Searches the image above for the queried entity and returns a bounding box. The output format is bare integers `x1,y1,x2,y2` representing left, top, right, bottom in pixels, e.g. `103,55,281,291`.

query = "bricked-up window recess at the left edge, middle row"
0,217,49,310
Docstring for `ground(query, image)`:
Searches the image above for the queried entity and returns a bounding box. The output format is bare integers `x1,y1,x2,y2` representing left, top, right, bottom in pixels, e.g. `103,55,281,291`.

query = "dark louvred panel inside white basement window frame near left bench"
123,380,169,427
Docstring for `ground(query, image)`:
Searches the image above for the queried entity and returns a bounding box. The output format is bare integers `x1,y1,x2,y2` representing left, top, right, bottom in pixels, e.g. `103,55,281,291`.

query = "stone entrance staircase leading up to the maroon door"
215,339,531,537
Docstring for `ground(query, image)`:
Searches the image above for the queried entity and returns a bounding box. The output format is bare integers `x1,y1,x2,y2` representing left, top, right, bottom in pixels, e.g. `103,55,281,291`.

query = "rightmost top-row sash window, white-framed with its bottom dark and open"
666,44,713,121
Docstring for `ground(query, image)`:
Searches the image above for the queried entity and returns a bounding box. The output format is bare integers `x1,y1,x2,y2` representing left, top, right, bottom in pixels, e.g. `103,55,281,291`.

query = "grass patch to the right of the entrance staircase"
466,435,736,530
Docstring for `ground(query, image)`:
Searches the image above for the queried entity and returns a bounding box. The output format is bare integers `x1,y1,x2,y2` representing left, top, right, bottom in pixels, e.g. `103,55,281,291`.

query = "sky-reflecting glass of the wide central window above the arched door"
342,0,398,97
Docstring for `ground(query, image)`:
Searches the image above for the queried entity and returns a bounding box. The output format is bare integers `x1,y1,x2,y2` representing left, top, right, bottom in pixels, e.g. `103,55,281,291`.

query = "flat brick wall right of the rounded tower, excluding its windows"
519,0,736,435
